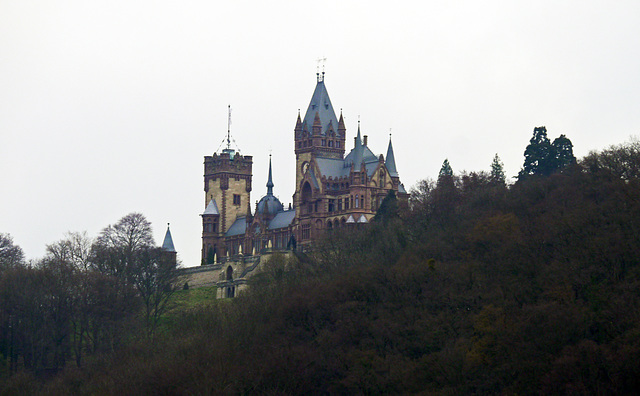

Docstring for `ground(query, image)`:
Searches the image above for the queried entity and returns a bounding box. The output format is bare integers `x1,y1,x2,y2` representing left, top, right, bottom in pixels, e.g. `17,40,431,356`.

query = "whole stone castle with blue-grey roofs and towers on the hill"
202,72,407,266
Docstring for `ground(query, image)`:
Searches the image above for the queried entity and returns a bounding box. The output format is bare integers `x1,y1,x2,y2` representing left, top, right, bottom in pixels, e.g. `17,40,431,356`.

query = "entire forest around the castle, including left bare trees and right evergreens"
0,127,640,395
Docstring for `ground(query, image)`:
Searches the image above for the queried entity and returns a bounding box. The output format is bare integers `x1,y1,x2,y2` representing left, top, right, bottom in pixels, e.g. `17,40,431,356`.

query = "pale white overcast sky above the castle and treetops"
0,0,640,266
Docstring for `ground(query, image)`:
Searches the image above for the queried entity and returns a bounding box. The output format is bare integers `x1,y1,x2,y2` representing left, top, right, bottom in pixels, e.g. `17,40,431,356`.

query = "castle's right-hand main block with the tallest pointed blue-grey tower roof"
293,73,407,245
